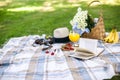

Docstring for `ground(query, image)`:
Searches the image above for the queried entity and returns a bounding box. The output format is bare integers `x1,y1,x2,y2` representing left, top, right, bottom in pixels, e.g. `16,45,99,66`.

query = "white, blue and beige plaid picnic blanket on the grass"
0,35,120,80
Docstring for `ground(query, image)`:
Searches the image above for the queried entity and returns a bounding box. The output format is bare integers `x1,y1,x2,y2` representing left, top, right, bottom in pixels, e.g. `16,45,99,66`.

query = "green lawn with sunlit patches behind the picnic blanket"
0,0,120,47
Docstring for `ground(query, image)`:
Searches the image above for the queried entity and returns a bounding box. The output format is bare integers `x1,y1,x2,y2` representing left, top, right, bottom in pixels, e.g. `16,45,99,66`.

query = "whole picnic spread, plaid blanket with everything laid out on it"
0,2,120,80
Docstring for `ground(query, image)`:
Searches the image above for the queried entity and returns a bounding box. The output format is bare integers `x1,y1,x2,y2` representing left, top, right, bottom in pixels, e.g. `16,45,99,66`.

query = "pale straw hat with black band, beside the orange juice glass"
53,27,69,43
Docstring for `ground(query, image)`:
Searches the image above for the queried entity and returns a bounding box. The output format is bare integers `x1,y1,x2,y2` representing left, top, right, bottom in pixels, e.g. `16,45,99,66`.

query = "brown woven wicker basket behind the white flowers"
81,1,105,40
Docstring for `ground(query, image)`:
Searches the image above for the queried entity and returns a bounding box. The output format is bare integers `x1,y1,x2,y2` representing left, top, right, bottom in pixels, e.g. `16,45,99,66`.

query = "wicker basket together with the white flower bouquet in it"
70,7,105,40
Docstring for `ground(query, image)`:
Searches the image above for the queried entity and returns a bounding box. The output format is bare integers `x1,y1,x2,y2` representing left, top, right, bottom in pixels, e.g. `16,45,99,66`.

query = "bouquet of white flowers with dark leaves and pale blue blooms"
70,7,94,35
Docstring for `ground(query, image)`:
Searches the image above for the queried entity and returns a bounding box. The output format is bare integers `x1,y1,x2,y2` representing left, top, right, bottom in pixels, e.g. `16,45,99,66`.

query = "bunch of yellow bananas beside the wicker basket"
104,28,119,43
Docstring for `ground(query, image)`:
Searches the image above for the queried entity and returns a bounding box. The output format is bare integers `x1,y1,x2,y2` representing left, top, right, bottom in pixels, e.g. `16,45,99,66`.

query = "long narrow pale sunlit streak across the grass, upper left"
7,3,80,12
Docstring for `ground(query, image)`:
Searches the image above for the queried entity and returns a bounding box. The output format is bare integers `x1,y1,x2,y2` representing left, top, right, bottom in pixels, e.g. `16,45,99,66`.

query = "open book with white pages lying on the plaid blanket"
69,38,104,59
